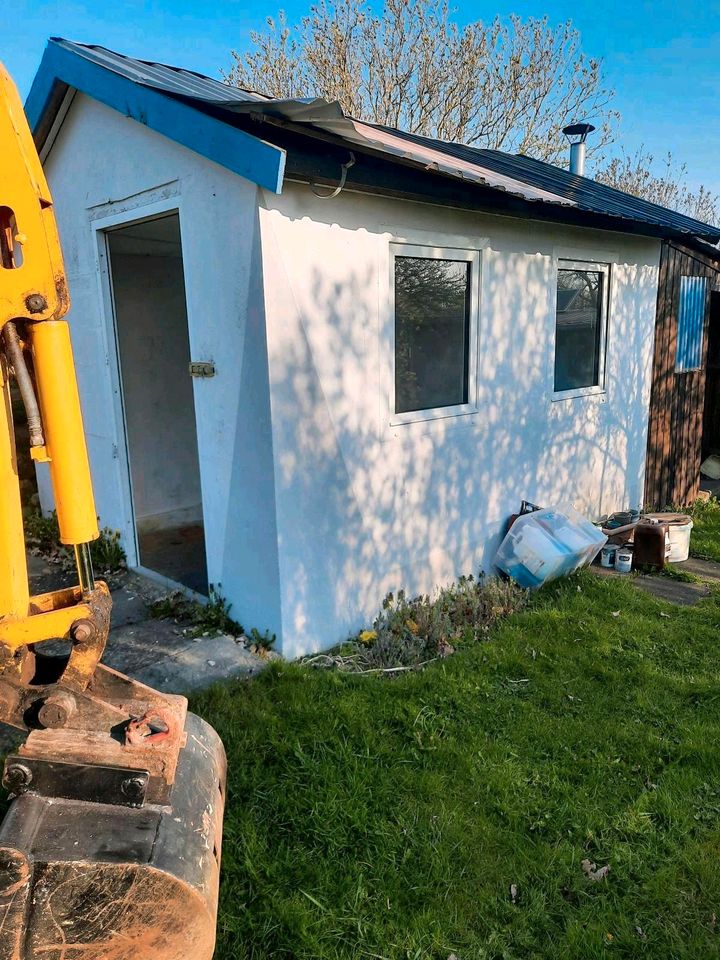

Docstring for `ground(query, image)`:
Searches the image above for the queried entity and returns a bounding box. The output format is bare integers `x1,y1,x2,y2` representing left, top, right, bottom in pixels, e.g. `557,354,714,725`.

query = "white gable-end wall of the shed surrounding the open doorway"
42,95,280,632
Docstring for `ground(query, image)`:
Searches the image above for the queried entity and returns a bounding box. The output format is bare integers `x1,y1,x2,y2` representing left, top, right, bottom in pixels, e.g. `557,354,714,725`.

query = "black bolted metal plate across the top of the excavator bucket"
3,754,150,807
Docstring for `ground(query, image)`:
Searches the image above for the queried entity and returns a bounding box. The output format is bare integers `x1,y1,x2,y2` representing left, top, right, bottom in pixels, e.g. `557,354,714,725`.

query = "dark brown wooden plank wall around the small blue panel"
645,243,720,509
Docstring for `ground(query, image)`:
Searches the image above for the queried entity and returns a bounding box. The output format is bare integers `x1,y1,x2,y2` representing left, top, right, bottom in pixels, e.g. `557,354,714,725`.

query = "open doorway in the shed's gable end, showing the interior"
107,213,208,594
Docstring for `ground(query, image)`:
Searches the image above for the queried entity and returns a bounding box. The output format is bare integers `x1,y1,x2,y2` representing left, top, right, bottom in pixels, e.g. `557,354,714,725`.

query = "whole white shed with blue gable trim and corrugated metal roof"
26,40,720,657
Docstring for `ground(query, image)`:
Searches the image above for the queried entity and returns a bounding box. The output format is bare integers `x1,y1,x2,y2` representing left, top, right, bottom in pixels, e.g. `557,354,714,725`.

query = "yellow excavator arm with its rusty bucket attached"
0,65,225,960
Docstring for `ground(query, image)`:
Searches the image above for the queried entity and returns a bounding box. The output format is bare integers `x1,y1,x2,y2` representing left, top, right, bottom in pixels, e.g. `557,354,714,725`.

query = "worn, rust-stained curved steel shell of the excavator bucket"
0,714,226,960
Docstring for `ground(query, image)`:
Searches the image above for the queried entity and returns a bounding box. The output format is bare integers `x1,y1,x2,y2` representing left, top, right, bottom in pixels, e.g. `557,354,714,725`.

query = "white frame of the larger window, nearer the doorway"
388,243,480,427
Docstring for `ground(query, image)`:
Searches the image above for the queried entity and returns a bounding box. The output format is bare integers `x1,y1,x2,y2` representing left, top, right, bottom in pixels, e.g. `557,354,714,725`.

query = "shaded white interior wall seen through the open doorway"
105,248,202,530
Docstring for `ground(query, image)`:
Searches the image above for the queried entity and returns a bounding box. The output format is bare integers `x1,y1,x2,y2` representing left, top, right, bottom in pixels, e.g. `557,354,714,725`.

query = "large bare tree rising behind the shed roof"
225,0,617,161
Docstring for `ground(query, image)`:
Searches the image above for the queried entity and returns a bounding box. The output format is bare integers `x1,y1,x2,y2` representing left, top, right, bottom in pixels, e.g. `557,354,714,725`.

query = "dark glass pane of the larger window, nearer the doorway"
395,257,470,413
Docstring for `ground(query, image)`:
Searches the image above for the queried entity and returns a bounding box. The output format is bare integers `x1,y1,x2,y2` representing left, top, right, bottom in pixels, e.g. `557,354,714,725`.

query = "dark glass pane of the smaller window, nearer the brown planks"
555,270,604,391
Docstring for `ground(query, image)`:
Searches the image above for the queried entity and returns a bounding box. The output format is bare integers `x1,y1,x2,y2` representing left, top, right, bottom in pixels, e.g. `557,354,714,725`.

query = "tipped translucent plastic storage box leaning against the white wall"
495,504,607,590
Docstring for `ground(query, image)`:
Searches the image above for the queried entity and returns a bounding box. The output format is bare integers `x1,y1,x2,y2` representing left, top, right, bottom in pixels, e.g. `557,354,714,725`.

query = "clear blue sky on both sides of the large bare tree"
5,0,720,192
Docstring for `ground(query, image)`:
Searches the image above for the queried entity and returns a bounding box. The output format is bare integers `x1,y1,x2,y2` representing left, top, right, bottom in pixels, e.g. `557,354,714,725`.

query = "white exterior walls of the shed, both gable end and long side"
40,97,659,657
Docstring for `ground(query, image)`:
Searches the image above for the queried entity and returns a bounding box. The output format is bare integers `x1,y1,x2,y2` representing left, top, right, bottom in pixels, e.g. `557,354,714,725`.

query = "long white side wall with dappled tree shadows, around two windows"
249,202,653,657
